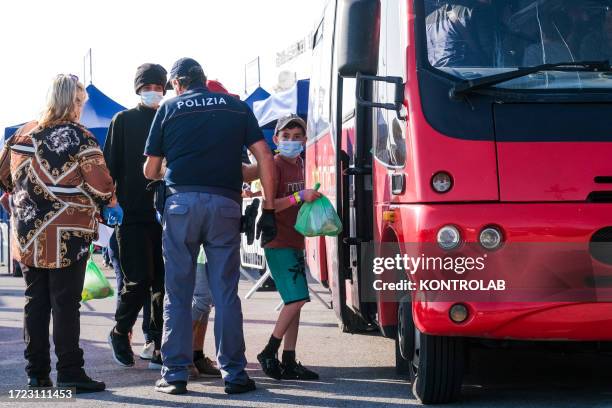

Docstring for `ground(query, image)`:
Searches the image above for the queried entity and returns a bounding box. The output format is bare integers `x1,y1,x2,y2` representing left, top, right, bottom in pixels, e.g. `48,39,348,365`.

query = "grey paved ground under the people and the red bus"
0,258,612,408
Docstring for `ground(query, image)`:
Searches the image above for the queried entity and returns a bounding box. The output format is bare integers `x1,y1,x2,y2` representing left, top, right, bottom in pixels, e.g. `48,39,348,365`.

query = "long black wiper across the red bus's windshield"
449,61,610,99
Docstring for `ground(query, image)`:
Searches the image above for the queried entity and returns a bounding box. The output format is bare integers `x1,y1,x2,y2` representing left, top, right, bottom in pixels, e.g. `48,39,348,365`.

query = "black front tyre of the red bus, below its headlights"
410,328,465,404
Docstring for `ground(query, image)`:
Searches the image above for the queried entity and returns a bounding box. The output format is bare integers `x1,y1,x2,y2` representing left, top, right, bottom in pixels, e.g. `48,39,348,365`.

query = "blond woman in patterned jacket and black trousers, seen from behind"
0,74,122,392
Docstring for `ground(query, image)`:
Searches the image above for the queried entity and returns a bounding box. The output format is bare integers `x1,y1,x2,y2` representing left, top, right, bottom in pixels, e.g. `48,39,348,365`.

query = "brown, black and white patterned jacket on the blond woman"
0,122,115,269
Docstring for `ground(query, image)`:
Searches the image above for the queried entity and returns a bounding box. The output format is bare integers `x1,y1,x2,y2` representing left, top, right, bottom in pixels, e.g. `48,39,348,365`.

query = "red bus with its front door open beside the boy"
306,0,612,403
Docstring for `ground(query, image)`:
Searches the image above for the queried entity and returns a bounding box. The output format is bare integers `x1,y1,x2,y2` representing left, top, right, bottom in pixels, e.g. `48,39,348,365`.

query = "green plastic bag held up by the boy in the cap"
295,183,342,237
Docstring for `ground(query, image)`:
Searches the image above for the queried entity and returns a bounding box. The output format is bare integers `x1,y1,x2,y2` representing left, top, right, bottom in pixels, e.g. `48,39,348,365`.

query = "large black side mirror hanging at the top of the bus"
337,0,381,78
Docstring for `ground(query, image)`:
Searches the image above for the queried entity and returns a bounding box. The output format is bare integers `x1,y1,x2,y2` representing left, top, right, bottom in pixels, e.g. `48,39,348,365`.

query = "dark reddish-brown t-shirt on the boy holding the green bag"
265,154,304,249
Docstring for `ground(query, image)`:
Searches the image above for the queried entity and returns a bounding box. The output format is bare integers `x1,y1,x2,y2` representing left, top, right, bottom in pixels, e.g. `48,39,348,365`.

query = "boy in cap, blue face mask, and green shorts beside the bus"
257,115,320,380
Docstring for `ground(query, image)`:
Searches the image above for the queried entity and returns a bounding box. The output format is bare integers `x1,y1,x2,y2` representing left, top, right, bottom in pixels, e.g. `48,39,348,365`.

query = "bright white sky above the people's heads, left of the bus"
0,0,326,134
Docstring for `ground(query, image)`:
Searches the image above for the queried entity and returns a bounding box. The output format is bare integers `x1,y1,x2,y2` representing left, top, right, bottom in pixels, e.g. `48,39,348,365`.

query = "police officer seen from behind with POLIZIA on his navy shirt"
144,58,276,394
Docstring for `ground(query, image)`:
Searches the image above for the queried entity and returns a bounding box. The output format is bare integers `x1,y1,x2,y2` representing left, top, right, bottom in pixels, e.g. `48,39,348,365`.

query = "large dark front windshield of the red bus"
424,0,612,89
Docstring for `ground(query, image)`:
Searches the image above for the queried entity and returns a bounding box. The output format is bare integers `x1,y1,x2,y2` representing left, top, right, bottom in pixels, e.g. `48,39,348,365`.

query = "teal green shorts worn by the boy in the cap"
264,248,310,305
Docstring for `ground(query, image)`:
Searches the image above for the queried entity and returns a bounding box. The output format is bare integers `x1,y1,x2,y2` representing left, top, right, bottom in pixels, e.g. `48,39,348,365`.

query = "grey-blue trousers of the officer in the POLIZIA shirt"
161,192,248,384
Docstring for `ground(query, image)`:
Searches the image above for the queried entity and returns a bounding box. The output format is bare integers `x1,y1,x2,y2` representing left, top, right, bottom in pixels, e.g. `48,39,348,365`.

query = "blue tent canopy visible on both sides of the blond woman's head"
2,85,125,146
